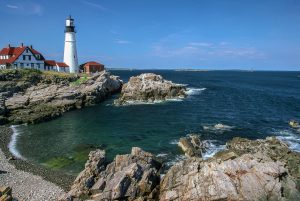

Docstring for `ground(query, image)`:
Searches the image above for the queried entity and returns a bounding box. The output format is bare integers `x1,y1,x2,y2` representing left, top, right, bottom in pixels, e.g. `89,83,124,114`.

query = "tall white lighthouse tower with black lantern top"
64,16,79,73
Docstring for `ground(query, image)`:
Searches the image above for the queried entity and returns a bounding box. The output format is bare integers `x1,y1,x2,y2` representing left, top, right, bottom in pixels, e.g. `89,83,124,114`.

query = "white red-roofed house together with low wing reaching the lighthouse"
0,43,70,72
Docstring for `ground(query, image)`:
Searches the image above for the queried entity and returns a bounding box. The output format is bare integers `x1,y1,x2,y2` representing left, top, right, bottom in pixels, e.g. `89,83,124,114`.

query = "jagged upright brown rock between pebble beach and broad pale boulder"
63,147,161,200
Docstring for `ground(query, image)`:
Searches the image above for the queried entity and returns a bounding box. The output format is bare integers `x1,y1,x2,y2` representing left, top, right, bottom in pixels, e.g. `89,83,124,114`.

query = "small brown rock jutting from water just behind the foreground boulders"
178,135,208,158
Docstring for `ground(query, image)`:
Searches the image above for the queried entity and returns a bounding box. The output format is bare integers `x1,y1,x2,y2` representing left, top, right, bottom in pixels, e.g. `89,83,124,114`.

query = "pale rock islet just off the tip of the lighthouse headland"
115,73,186,105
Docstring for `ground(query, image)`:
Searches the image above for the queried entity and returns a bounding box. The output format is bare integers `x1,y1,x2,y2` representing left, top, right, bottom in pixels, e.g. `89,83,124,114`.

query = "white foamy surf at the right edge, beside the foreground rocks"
273,129,300,152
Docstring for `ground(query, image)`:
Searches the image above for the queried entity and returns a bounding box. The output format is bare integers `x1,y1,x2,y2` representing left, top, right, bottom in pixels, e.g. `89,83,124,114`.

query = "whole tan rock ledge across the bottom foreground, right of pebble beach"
62,136,300,201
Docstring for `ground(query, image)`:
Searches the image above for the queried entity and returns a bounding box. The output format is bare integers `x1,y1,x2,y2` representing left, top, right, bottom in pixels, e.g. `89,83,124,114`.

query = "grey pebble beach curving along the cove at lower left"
0,126,74,201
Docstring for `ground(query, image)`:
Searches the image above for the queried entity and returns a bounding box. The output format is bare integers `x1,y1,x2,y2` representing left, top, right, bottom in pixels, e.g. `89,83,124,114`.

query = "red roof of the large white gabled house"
0,46,41,64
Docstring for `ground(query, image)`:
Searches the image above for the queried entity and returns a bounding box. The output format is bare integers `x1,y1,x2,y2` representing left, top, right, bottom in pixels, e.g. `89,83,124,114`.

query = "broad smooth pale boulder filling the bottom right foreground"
159,154,299,201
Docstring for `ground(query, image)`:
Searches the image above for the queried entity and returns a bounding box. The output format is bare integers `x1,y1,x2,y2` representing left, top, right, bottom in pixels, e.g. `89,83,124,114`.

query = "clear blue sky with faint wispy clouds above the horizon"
0,0,300,70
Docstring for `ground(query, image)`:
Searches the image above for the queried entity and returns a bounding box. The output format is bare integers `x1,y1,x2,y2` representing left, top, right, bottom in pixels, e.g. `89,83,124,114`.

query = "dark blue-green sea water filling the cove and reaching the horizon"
15,70,300,172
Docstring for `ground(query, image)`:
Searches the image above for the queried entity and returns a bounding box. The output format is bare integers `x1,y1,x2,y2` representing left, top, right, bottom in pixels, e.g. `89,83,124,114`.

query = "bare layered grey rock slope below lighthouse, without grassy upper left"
0,71,122,123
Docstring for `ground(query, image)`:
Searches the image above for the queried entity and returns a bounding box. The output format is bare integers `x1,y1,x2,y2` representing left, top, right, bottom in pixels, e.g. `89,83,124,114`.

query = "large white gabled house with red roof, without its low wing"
0,43,44,70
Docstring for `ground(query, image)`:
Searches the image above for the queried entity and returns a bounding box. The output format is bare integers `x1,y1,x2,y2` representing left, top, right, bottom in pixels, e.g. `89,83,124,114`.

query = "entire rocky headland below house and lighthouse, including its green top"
0,70,122,124
